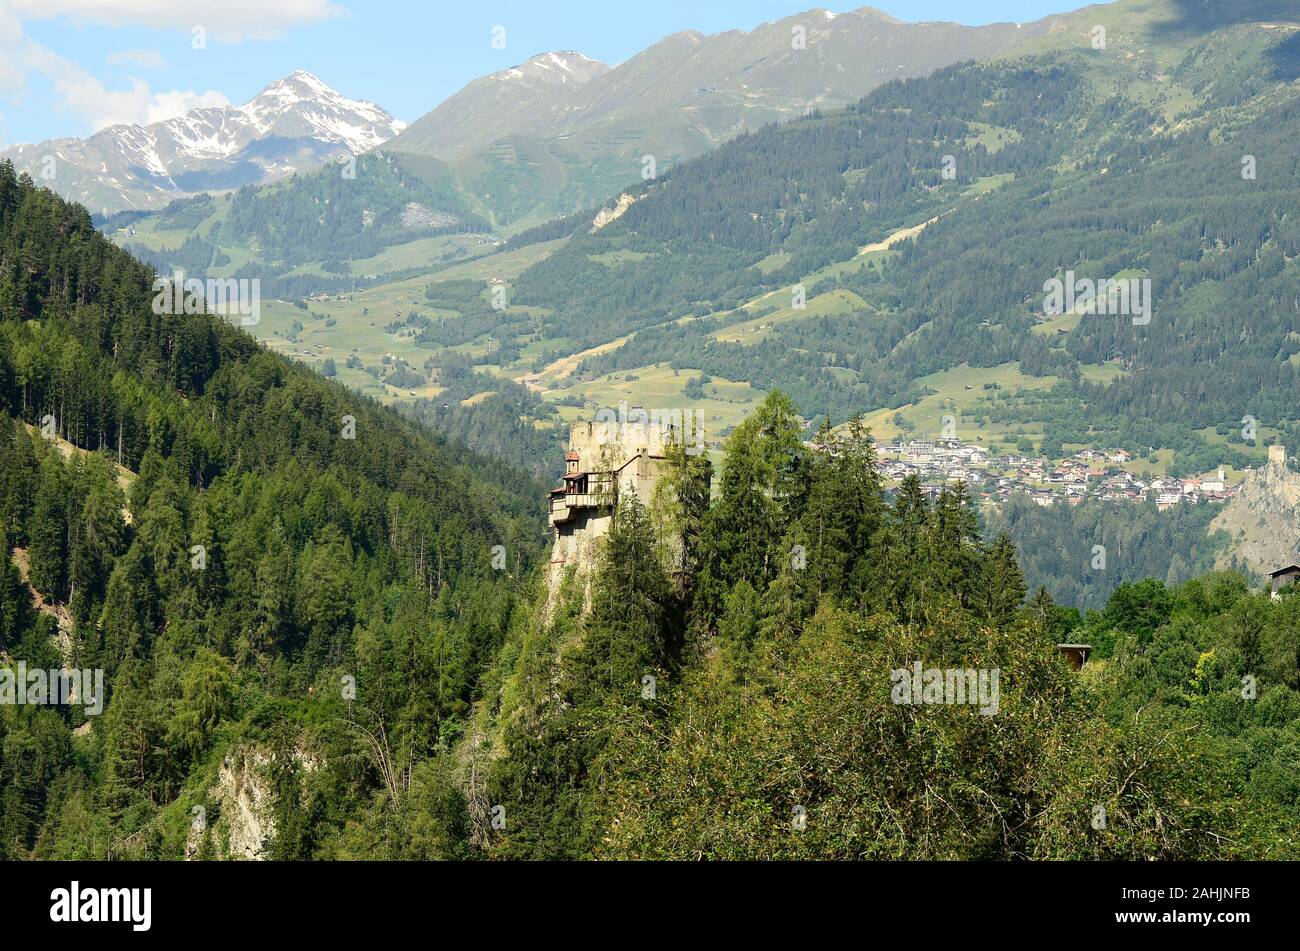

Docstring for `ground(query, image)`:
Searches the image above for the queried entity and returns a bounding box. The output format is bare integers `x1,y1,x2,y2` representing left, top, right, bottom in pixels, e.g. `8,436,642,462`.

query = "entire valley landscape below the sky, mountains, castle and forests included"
0,0,1300,861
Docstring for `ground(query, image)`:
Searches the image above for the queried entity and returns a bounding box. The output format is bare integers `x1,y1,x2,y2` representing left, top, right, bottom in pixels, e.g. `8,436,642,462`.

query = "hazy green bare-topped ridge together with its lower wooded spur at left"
92,9,1060,306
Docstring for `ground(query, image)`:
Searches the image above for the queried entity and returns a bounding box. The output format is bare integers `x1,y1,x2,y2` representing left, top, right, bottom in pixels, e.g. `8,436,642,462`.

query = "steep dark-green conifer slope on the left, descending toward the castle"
0,165,541,859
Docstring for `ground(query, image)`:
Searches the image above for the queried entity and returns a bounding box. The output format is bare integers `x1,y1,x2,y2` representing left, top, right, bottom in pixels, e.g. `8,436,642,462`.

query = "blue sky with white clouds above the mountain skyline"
0,0,1084,146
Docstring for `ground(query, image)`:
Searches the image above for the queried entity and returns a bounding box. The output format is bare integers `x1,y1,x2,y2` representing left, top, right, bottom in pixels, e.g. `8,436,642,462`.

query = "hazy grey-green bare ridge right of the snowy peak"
389,8,1057,225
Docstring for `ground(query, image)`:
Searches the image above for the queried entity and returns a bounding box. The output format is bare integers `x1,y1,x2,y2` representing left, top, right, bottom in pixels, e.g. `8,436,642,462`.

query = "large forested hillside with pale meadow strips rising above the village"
512,4,1300,464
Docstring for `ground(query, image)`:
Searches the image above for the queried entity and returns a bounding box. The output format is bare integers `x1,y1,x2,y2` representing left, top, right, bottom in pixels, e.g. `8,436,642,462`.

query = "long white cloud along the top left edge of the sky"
0,0,346,43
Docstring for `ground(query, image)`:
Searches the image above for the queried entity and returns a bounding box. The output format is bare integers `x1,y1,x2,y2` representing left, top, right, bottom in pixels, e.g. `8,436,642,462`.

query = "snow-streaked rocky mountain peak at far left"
0,70,406,214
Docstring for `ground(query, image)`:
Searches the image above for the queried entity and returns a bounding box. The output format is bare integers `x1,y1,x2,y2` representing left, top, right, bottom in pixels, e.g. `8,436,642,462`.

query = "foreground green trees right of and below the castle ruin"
481,394,1300,860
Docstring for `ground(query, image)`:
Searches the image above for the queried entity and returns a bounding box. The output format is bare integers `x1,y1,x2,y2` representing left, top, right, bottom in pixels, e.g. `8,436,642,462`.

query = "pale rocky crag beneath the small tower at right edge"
1210,452,1300,574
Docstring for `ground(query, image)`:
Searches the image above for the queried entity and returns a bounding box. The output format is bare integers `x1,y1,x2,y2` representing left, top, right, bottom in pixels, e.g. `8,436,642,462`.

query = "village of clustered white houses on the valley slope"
876,438,1239,511
